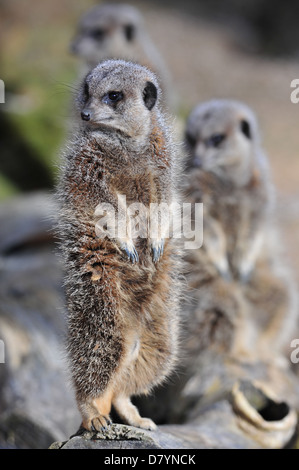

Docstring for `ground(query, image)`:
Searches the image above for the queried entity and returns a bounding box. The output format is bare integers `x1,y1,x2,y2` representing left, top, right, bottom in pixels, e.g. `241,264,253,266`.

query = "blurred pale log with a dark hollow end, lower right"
135,351,299,448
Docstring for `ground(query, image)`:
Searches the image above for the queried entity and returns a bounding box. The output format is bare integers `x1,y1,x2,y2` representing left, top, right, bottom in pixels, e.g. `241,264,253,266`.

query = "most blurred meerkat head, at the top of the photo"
70,4,144,67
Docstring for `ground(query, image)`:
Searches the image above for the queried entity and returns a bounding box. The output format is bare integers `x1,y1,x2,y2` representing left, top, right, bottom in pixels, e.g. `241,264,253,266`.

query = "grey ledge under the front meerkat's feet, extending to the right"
50,392,294,449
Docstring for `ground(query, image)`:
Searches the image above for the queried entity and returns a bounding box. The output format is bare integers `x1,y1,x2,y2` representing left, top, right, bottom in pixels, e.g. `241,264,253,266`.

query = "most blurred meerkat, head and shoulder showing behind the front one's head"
70,3,173,106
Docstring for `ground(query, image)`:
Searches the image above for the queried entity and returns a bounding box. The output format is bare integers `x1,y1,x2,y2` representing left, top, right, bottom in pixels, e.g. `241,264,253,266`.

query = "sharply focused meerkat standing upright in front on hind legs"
57,60,180,431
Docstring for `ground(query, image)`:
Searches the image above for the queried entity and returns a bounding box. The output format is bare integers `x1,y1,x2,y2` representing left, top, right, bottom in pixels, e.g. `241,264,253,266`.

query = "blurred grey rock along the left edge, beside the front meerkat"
0,193,80,448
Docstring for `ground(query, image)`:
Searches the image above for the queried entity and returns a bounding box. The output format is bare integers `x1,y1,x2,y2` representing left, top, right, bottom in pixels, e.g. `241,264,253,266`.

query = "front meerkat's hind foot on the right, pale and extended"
113,396,157,431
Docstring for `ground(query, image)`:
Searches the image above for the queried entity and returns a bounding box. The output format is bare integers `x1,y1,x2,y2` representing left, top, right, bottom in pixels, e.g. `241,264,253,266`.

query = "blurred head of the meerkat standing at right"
185,100,260,185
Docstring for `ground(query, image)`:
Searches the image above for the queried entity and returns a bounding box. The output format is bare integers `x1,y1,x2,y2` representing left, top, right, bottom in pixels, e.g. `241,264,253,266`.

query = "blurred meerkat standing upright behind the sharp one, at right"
185,100,297,355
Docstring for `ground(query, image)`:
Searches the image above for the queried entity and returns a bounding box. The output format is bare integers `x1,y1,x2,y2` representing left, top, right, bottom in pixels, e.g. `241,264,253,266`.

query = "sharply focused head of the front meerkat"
77,60,160,143
